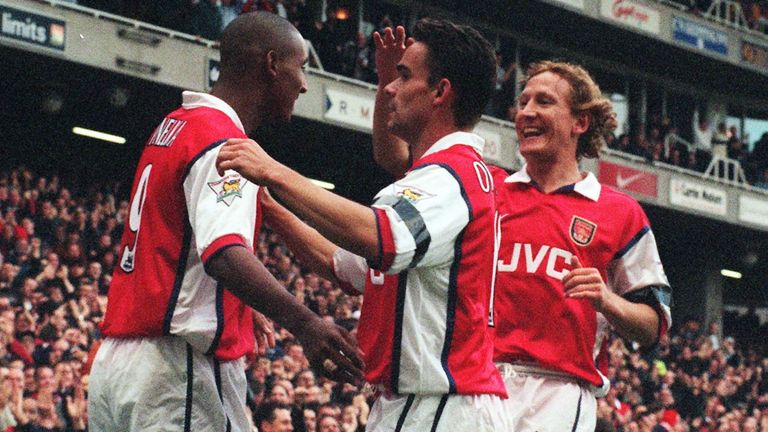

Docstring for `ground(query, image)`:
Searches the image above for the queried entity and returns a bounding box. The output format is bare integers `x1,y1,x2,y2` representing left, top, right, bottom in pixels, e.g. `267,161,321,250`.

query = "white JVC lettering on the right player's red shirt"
498,243,573,280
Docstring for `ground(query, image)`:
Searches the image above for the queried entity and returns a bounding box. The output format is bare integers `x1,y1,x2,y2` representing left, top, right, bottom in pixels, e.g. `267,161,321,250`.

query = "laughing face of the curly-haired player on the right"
515,72,588,161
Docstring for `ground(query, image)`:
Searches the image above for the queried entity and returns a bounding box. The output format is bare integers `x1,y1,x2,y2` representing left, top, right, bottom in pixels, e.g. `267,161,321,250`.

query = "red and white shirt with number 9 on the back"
102,92,259,361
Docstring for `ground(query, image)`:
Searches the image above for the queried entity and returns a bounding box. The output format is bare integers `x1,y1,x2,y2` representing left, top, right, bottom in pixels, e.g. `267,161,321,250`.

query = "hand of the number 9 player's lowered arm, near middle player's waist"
297,318,363,385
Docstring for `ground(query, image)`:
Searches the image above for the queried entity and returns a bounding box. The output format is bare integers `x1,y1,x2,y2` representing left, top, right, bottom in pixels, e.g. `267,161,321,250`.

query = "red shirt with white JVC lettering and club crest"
491,167,671,386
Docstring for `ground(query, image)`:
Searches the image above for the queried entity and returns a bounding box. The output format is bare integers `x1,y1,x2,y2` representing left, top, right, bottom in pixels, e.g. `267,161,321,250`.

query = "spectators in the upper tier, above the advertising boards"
60,0,768,188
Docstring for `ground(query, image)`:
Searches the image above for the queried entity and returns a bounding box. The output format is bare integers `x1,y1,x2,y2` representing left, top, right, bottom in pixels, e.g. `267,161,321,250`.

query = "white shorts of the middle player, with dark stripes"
365,395,513,432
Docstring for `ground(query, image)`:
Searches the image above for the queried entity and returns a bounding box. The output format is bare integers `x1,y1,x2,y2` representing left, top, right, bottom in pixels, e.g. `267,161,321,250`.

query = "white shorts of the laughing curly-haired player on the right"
497,363,597,432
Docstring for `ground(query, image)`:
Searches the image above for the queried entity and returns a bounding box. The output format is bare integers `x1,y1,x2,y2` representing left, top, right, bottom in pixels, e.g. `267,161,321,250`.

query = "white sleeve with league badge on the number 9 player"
184,143,259,262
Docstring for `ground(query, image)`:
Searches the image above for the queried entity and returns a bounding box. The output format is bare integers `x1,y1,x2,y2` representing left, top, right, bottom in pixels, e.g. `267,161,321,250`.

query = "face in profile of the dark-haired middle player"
384,42,434,143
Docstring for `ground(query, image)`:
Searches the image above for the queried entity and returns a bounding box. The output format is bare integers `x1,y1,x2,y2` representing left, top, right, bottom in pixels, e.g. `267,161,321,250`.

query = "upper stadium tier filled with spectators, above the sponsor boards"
61,0,768,189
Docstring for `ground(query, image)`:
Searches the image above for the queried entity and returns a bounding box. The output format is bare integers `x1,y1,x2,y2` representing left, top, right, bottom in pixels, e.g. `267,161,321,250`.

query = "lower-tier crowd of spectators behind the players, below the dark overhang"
0,167,768,432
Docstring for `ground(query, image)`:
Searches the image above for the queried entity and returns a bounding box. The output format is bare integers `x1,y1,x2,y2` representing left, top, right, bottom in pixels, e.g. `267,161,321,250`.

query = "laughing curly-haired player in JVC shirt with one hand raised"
373,29,671,432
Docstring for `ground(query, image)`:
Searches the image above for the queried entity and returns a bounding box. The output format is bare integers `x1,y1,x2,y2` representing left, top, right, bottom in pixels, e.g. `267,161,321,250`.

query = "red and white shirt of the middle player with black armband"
334,132,506,396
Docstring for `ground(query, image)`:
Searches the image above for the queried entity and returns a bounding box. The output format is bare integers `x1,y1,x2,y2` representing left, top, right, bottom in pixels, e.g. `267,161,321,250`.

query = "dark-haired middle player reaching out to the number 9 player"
217,19,510,432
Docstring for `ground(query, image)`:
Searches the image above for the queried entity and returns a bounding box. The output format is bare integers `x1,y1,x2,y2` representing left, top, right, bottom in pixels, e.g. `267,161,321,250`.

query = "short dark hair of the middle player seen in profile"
413,18,496,128
